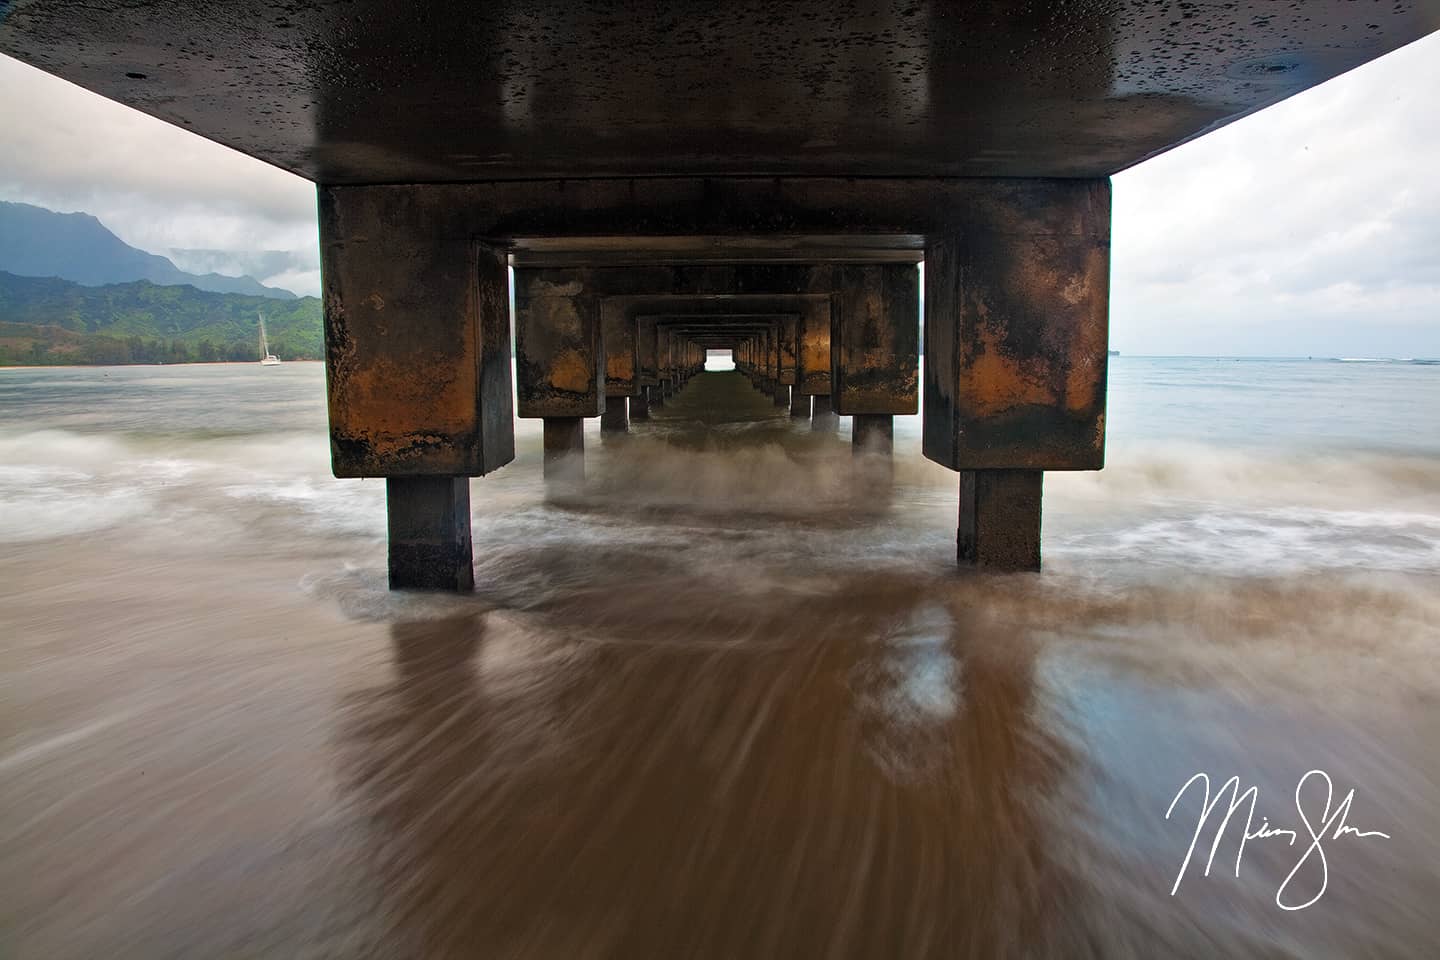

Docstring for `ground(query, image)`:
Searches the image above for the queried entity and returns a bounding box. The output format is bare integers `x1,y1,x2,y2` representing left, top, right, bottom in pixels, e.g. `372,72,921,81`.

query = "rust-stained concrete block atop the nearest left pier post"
320,189,514,476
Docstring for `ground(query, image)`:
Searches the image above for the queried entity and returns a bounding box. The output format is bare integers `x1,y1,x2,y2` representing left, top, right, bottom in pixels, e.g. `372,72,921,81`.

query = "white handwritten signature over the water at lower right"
1165,770,1390,910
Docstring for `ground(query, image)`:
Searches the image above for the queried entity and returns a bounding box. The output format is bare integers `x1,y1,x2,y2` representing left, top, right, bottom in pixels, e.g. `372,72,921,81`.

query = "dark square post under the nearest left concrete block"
384,476,475,592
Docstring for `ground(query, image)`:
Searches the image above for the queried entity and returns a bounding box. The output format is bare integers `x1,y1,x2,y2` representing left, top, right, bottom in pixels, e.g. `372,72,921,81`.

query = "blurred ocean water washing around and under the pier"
0,357,1440,959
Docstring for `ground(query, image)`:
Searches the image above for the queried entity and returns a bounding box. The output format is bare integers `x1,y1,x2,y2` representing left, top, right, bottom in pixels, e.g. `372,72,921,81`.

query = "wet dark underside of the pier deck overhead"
8,0,1440,182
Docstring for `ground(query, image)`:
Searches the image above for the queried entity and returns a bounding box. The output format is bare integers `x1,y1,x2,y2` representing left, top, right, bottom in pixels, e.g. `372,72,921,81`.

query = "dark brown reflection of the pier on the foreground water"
343,583,1071,957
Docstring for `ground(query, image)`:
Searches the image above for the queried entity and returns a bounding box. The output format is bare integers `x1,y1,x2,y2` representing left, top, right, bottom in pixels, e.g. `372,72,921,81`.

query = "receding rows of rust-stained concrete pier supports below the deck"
320,177,1110,590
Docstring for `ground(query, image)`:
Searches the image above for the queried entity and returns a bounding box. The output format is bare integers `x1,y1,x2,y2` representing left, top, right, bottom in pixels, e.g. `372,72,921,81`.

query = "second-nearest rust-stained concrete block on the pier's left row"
516,269,605,417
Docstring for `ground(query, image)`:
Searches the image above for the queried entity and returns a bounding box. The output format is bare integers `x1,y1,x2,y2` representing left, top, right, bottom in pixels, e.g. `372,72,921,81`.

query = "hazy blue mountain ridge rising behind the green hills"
0,201,295,299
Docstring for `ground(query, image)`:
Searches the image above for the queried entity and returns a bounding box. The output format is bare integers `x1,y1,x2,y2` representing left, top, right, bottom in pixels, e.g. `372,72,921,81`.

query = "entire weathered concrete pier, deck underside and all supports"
0,0,1440,590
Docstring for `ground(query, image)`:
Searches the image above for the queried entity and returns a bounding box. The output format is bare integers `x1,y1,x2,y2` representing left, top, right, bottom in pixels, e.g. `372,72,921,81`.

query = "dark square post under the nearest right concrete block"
956,471,1044,570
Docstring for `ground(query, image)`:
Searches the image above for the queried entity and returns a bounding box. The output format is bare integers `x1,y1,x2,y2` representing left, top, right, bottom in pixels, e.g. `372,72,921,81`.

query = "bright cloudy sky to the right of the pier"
1112,35,1440,356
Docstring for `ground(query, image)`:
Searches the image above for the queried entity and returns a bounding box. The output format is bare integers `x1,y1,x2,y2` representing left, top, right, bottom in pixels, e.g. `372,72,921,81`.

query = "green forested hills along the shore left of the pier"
0,272,324,366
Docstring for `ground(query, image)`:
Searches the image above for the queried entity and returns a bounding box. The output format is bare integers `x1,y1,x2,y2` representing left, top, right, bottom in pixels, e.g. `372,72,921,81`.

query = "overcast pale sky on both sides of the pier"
0,35,1440,357
